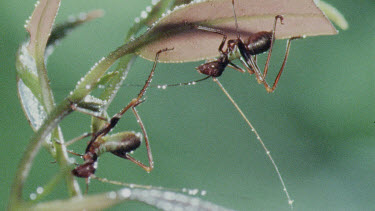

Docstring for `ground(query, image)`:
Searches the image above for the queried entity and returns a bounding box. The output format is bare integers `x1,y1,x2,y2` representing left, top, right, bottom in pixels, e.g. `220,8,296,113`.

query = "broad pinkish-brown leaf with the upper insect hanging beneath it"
138,0,337,62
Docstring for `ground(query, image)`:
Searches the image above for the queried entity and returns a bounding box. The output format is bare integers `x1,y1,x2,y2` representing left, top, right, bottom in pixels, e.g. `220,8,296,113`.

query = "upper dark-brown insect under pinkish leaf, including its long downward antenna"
180,0,302,208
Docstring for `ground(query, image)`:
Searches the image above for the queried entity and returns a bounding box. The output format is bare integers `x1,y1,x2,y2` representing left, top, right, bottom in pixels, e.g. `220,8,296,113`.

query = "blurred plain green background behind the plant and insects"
0,0,375,210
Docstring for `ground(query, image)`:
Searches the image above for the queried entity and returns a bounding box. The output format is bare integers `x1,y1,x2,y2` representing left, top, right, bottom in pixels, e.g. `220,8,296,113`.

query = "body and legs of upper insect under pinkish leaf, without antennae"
195,0,301,92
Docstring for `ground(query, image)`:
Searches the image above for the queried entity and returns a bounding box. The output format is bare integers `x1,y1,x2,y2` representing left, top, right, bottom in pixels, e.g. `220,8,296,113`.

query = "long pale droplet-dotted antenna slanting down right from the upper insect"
212,77,293,209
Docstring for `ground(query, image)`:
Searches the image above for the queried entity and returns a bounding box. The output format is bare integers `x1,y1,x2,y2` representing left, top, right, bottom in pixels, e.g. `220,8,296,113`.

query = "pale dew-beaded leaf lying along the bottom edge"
29,188,232,211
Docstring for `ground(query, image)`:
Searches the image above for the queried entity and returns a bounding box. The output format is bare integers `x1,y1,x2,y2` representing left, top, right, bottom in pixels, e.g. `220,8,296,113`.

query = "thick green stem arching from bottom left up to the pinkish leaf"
8,14,189,210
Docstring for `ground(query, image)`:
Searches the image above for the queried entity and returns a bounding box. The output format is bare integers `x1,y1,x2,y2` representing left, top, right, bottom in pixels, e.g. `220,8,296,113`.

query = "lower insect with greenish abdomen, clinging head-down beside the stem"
66,48,173,192
